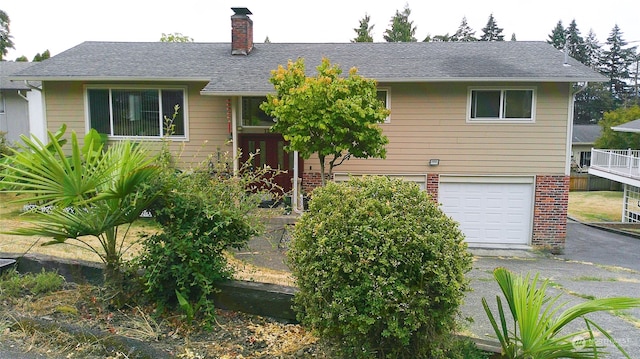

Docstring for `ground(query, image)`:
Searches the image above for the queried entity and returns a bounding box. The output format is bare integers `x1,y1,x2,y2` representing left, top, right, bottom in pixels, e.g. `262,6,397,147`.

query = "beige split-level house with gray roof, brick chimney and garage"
15,8,606,250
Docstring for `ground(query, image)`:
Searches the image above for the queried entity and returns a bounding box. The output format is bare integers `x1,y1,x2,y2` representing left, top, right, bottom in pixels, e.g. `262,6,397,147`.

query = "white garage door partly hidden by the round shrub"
438,176,534,246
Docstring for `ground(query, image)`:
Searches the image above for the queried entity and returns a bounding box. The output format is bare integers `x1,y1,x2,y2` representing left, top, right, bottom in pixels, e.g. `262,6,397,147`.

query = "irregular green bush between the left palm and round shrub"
137,150,278,326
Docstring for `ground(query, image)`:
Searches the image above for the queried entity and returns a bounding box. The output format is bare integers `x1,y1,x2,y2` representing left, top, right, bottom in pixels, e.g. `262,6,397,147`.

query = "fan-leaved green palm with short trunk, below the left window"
2,127,158,290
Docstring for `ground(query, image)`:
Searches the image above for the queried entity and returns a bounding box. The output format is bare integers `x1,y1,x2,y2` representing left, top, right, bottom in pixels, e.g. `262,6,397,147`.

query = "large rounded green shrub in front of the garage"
288,177,472,358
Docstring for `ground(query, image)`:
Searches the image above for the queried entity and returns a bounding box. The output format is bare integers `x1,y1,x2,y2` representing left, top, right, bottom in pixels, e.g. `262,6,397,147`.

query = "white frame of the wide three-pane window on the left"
84,84,189,141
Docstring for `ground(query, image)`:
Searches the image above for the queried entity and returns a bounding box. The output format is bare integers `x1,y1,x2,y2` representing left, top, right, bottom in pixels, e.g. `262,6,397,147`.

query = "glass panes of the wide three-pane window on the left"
87,88,186,137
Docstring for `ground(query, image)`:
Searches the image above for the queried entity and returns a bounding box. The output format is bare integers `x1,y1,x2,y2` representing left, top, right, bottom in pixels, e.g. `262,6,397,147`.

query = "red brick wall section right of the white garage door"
531,176,569,252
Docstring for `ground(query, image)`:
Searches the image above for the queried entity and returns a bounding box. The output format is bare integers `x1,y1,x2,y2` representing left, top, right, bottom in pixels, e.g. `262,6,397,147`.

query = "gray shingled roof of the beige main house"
11,41,607,94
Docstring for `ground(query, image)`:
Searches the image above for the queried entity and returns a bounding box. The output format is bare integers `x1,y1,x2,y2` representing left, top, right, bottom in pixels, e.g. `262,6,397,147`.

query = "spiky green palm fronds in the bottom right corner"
482,268,640,359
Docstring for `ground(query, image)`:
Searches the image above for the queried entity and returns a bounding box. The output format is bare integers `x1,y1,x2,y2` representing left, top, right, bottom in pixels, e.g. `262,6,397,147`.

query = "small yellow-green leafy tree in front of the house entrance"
260,58,389,185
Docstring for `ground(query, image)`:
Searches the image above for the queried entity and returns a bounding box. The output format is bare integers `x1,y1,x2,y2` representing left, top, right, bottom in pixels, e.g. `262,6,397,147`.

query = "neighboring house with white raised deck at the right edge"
589,119,640,222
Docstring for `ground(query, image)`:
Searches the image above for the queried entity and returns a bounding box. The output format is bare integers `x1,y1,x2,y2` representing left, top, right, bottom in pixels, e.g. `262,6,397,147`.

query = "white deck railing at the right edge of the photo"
590,148,640,179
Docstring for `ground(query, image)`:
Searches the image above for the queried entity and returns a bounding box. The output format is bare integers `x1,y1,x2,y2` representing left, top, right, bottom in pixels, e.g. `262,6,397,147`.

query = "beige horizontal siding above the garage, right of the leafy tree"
305,83,569,175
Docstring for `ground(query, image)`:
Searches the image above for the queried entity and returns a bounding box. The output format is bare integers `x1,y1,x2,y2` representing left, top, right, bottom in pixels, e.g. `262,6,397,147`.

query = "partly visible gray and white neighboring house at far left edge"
0,61,46,143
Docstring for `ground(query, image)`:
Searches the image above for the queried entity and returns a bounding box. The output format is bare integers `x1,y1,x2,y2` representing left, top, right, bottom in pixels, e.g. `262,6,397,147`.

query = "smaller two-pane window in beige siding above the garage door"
469,89,535,121
